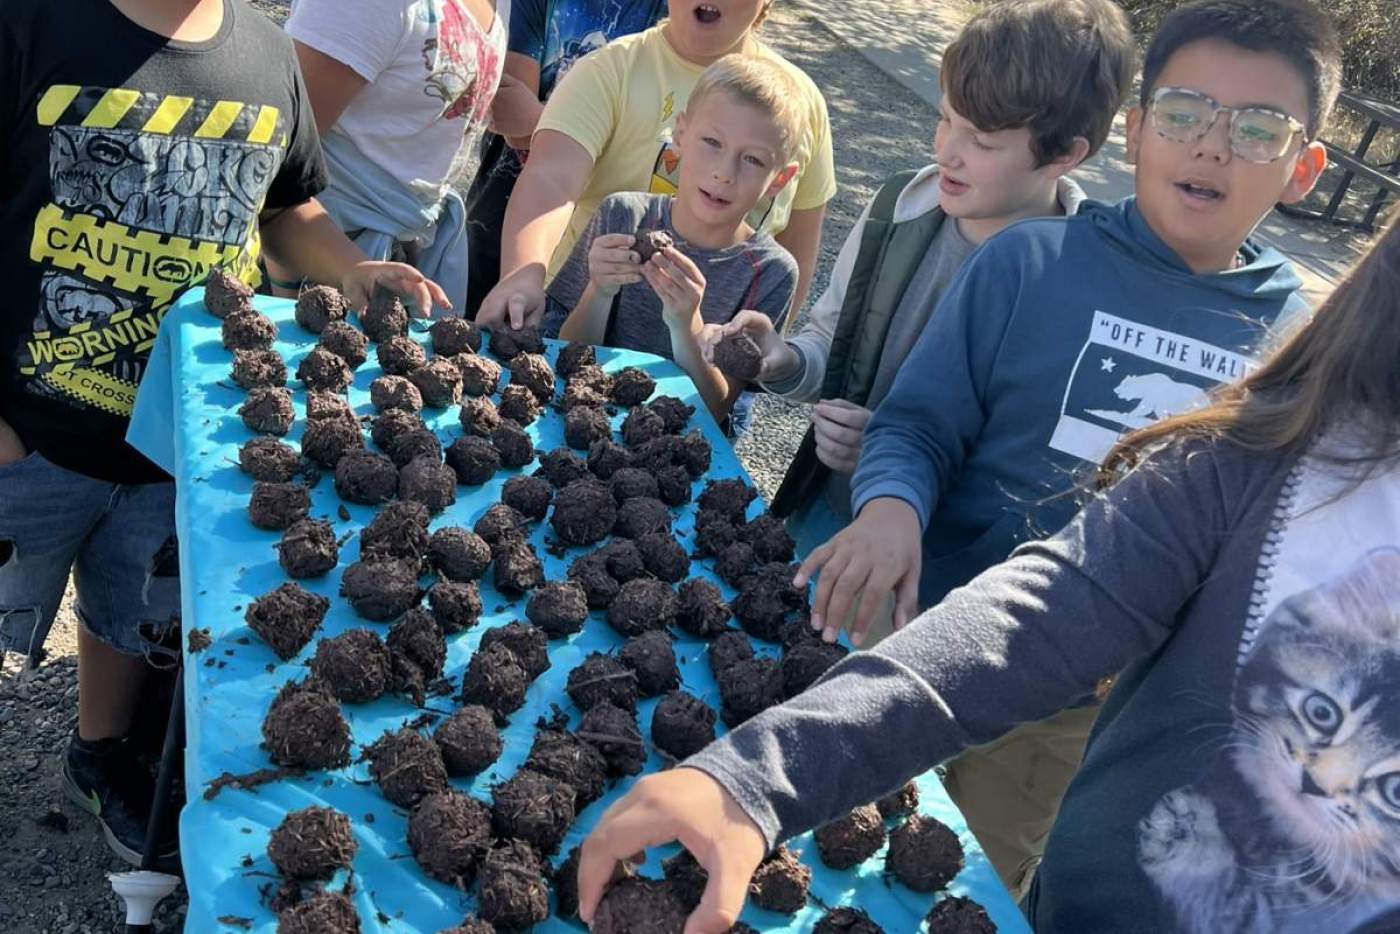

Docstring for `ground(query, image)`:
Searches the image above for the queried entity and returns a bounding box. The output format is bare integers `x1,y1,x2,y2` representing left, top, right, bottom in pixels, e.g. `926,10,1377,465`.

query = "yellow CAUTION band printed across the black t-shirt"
29,204,258,304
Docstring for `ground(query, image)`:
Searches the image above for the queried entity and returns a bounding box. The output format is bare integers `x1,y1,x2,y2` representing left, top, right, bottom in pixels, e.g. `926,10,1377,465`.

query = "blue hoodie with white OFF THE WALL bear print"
851,197,1306,606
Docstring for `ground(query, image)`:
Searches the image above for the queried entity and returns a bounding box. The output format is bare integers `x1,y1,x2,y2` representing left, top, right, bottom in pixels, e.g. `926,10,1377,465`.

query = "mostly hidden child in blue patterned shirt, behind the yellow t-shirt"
465,0,666,308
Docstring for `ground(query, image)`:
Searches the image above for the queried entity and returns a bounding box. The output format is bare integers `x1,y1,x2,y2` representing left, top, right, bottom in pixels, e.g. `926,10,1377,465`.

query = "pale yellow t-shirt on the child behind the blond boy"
536,25,836,279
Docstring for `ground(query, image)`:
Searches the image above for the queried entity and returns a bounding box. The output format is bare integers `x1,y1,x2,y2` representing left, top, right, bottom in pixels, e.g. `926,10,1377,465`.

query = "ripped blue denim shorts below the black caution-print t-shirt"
0,451,179,662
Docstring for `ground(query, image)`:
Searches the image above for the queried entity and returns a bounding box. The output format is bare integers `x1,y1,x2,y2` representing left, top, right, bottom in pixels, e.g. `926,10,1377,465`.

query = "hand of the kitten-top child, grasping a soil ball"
578,767,767,934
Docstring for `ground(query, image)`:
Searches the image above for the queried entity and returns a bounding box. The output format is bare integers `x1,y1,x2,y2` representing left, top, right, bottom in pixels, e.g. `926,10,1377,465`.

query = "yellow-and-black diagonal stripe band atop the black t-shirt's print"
36,84,287,146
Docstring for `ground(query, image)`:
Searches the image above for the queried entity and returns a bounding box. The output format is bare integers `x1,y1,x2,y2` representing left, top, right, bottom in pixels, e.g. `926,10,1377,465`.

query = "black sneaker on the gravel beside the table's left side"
63,732,178,865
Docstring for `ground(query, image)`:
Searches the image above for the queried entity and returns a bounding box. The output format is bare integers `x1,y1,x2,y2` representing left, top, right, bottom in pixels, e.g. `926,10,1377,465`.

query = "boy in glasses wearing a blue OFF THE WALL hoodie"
798,0,1338,907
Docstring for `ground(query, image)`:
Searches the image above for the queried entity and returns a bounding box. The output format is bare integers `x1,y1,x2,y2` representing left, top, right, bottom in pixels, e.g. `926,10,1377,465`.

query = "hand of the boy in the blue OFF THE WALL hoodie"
792,496,923,646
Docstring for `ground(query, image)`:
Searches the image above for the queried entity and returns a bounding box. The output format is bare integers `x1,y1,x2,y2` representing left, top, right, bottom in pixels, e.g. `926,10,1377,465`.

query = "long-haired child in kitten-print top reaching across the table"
578,205,1400,934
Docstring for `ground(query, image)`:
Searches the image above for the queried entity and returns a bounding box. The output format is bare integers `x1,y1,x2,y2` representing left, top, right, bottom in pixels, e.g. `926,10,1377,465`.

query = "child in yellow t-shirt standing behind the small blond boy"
477,0,836,328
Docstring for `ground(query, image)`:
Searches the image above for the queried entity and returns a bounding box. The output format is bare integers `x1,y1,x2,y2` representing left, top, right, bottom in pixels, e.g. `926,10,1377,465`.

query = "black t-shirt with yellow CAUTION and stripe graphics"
0,0,325,483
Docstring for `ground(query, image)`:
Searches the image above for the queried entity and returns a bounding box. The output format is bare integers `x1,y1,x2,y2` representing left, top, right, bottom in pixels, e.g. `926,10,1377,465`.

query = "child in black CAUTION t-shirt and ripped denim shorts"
0,0,445,863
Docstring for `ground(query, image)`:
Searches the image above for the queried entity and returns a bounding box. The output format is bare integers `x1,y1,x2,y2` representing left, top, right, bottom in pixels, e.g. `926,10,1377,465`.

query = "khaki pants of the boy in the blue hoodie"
944,704,1099,902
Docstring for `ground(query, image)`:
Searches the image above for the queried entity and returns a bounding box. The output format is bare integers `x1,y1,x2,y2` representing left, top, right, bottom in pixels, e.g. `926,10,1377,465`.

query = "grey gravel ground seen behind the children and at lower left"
0,0,934,934
